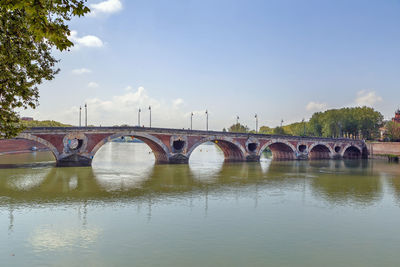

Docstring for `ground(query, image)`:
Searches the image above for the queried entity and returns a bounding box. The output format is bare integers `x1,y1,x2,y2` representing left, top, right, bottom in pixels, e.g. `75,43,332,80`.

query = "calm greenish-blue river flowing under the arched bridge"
0,143,400,266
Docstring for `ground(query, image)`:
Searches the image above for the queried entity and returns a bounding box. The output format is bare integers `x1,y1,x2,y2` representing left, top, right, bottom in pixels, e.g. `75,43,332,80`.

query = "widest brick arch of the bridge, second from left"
89,132,170,163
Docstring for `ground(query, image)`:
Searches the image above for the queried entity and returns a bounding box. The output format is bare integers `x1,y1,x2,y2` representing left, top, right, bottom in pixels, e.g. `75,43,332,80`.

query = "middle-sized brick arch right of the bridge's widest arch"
187,136,246,161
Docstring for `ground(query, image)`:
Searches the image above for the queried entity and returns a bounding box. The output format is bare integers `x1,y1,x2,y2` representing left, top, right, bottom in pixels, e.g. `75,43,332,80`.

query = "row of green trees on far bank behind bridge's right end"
228,107,400,141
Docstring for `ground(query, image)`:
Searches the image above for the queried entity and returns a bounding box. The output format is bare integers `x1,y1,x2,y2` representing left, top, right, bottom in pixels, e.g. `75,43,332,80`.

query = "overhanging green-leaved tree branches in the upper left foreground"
0,0,90,138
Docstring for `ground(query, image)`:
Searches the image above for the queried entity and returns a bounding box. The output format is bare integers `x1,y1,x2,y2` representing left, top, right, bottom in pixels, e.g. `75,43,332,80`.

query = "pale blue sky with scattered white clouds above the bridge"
21,0,400,130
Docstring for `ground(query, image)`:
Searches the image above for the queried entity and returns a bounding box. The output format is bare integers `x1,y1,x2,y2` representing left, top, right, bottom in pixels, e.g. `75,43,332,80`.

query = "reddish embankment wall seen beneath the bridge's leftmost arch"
0,139,48,155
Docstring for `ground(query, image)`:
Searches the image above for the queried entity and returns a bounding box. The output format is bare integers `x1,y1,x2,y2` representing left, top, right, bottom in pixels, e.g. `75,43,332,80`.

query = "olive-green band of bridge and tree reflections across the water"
0,148,400,208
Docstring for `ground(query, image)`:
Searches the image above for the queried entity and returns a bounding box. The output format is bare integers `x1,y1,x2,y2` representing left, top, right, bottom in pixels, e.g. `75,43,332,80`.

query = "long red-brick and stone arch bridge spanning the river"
18,127,368,166
